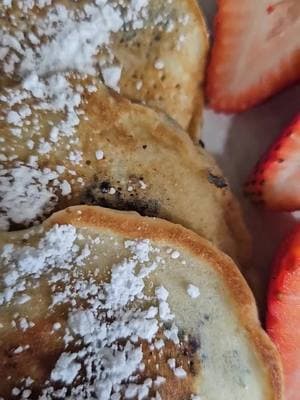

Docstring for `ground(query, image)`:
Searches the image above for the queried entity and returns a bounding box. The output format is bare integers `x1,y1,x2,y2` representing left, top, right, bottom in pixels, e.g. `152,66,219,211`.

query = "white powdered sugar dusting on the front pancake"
0,225,195,400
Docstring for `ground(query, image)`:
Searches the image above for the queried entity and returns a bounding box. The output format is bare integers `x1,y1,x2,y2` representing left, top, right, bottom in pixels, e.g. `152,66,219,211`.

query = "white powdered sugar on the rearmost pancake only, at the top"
0,0,149,89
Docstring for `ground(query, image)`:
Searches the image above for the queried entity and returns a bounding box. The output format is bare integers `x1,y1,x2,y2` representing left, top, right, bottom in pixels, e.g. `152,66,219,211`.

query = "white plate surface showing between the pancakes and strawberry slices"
199,0,300,304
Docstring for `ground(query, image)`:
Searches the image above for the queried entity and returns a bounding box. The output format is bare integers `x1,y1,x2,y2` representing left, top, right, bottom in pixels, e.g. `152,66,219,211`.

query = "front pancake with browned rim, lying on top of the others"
0,206,283,400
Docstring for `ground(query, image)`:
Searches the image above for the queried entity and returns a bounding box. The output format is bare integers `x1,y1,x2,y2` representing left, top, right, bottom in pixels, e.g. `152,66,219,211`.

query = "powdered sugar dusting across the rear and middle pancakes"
0,0,190,230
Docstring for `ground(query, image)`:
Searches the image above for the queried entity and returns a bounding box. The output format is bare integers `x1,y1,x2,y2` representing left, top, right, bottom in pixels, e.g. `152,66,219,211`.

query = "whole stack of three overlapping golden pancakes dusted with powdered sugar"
0,0,282,400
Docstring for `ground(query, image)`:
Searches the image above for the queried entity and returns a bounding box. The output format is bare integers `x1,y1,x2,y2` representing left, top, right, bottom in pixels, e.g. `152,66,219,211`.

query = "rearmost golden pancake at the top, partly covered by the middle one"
0,0,208,140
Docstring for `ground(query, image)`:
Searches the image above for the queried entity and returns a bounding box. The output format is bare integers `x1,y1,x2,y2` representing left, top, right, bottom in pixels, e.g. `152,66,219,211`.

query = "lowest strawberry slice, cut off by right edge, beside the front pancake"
266,225,300,400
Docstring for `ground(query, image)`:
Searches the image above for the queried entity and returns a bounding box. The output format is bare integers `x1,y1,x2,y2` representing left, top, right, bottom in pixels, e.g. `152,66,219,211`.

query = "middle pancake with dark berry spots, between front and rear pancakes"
0,74,250,265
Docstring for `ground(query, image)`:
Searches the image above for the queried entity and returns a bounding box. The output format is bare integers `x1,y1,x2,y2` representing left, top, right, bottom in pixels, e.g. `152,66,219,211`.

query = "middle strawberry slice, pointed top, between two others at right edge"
245,114,300,211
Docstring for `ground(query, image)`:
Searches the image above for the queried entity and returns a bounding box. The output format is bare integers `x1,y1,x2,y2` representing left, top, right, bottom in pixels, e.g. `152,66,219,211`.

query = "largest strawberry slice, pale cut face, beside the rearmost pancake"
206,0,300,112
